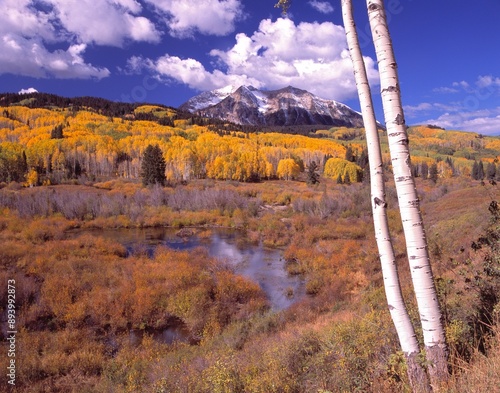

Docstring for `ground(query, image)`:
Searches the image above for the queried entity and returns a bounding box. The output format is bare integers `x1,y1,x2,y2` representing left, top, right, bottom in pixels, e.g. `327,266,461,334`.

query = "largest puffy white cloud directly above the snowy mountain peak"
139,18,378,101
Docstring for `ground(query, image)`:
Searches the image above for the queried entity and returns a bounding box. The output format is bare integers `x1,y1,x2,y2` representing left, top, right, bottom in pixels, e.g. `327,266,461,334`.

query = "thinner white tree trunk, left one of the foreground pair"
341,0,430,392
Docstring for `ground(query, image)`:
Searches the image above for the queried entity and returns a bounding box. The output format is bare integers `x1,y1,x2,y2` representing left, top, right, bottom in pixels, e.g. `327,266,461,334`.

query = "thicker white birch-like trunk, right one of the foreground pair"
367,0,449,389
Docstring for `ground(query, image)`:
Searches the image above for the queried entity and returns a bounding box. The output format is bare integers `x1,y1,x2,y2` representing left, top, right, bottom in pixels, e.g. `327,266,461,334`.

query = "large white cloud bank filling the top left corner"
0,0,160,78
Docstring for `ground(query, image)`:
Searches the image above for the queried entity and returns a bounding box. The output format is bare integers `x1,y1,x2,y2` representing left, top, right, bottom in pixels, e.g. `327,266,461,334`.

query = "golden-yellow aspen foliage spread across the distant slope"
0,105,500,183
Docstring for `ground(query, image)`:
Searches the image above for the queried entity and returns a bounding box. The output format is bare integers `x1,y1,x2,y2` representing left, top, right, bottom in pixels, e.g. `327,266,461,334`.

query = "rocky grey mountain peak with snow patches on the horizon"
179,86,363,127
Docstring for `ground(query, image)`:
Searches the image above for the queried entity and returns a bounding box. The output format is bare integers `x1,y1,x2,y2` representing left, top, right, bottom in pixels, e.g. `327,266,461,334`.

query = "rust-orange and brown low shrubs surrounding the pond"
0,175,498,392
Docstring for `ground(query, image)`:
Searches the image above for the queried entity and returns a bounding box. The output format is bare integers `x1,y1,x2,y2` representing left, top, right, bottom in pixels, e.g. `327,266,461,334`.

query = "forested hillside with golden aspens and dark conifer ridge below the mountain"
0,93,500,184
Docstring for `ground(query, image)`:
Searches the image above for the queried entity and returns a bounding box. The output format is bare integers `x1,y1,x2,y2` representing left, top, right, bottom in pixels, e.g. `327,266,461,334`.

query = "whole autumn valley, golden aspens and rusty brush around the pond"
0,99,500,393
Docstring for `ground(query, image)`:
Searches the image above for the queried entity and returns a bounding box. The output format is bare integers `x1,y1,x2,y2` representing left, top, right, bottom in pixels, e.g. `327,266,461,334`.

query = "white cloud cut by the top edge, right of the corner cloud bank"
146,0,243,37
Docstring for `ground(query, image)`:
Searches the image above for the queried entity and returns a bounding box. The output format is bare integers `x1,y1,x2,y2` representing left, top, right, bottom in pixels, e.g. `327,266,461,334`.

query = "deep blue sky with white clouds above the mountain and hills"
0,0,500,135
